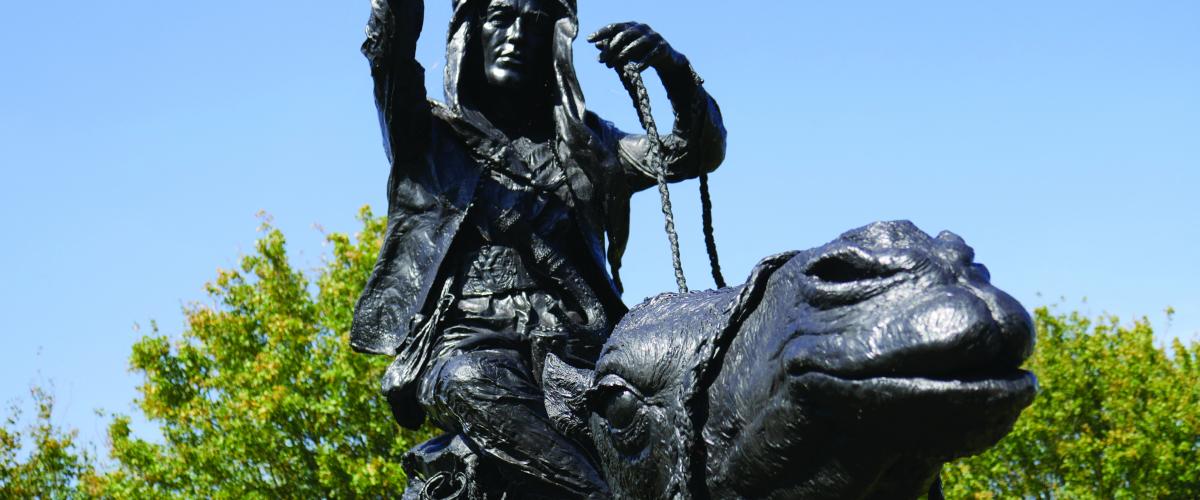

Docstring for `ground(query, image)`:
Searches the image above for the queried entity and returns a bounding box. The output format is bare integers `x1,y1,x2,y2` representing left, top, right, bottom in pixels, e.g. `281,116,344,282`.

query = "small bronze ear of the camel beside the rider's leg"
541,353,594,444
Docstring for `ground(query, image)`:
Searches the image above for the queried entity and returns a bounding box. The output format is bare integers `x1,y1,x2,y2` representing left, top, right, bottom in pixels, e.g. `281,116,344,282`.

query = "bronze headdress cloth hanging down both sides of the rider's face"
434,0,630,296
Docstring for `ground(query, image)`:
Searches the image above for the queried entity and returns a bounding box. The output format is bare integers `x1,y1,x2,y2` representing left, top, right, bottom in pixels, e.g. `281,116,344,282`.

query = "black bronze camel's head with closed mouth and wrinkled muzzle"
587,222,1036,498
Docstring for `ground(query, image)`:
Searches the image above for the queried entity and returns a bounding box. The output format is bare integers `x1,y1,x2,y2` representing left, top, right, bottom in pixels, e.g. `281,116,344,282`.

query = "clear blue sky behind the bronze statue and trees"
0,0,1200,442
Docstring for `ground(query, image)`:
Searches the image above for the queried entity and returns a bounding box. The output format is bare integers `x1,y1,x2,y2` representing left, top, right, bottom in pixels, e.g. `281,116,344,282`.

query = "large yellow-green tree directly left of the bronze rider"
92,209,428,499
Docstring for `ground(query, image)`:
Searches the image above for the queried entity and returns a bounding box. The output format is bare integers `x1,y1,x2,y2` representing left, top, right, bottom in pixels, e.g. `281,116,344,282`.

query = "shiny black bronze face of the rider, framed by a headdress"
480,0,557,90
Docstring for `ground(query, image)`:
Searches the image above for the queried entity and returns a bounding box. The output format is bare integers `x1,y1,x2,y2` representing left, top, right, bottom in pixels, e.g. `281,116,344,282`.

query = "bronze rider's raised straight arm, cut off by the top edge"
362,0,430,164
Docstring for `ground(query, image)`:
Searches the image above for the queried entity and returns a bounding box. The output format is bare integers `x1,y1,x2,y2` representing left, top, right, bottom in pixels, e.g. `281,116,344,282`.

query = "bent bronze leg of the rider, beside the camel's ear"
421,349,608,498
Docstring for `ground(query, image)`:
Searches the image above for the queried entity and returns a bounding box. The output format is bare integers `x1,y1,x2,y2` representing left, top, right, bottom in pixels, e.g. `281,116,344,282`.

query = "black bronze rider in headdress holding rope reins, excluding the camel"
352,0,725,498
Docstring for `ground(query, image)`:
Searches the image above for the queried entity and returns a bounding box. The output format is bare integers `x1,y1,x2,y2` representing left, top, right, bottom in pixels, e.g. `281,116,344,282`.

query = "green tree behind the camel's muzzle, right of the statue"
943,308,1200,499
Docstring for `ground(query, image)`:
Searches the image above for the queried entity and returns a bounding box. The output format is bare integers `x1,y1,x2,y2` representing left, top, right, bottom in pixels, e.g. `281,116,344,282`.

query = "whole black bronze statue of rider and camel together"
352,0,1036,499
